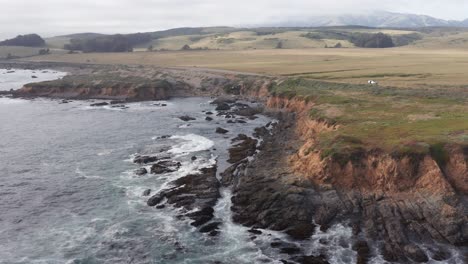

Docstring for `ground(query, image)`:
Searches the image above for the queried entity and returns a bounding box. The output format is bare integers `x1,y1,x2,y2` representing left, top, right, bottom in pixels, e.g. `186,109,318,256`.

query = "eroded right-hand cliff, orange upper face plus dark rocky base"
233,97,468,263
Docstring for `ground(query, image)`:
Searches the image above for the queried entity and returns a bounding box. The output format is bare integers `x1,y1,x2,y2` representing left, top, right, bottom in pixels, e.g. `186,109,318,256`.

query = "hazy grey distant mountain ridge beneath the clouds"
270,11,468,28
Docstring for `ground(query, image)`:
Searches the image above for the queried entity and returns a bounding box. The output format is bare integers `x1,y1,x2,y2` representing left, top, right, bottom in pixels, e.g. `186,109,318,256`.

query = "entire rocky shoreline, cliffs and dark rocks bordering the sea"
1,61,468,264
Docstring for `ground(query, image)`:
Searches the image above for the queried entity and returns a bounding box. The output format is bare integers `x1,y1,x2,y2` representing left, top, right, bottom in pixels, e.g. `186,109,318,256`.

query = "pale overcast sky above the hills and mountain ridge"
0,0,468,38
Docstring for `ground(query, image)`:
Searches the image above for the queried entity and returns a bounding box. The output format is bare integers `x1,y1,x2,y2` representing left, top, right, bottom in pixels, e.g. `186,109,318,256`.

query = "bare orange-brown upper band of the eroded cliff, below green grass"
267,97,468,196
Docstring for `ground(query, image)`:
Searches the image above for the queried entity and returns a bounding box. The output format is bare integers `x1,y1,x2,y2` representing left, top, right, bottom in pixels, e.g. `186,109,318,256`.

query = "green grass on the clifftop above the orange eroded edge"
272,78,468,155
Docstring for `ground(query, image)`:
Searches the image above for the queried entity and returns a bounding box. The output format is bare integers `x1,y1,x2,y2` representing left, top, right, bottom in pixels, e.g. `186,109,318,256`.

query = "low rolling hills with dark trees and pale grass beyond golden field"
47,27,438,52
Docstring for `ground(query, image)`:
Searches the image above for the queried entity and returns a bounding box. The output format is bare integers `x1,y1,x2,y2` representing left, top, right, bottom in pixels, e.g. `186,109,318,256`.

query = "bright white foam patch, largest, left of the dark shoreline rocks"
168,134,214,155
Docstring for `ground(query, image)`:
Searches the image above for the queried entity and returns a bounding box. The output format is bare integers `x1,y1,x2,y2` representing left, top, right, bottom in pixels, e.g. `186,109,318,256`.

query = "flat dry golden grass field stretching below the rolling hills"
27,47,468,88
